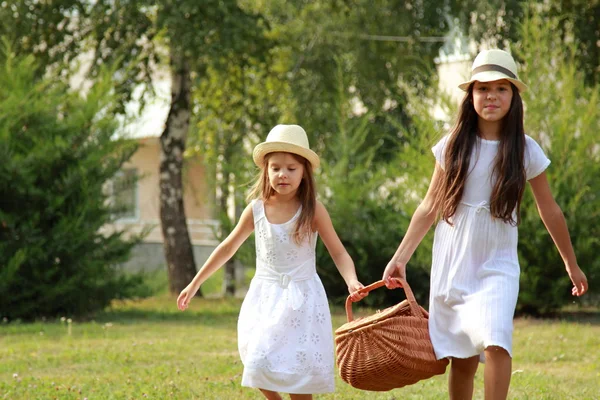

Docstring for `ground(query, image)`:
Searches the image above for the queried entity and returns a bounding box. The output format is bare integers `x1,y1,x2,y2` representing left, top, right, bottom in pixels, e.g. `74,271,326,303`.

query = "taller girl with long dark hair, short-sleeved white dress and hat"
383,50,588,400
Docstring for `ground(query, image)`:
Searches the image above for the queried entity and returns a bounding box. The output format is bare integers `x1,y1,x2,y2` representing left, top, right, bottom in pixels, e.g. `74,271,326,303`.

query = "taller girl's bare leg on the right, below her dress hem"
483,346,512,400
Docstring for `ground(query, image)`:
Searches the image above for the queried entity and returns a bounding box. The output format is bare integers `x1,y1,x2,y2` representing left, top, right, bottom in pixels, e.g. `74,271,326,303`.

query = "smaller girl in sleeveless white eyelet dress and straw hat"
177,125,364,400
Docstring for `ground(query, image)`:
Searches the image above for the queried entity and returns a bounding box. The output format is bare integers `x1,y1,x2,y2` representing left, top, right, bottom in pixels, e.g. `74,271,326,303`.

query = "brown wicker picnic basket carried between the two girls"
335,280,448,391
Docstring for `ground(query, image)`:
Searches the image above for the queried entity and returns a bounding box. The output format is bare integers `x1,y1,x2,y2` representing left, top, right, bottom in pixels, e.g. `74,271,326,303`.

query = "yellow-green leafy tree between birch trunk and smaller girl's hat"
190,59,291,295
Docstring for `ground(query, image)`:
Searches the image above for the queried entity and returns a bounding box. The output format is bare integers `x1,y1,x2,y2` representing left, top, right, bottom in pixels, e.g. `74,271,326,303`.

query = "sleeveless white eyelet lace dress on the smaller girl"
238,200,334,394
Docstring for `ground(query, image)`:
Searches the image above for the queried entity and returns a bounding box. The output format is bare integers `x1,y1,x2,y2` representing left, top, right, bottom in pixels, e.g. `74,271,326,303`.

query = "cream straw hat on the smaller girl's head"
252,125,320,169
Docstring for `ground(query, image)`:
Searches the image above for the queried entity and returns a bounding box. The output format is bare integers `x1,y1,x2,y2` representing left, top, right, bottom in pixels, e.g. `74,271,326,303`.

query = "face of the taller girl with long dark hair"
473,79,513,122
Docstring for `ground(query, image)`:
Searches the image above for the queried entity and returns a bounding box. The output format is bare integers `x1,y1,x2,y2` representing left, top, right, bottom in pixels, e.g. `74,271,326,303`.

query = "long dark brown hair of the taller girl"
434,83,526,225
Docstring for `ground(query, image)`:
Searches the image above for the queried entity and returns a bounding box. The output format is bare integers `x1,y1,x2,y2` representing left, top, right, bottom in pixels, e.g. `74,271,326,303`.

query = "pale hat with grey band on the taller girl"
458,50,527,93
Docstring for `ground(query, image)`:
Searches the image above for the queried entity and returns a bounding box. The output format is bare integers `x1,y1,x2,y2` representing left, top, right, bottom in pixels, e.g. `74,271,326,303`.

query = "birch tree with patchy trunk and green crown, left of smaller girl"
84,0,264,293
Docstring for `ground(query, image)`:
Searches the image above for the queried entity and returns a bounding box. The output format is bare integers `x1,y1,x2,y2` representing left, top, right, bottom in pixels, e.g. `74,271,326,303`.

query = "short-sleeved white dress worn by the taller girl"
429,135,550,362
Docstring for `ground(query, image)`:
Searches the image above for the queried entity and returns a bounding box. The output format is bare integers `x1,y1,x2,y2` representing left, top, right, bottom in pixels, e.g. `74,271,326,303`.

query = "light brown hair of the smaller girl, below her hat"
247,153,317,244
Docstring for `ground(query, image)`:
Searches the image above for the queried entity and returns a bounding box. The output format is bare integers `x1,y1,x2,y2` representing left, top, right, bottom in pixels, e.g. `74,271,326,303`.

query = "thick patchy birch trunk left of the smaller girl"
159,49,201,295
